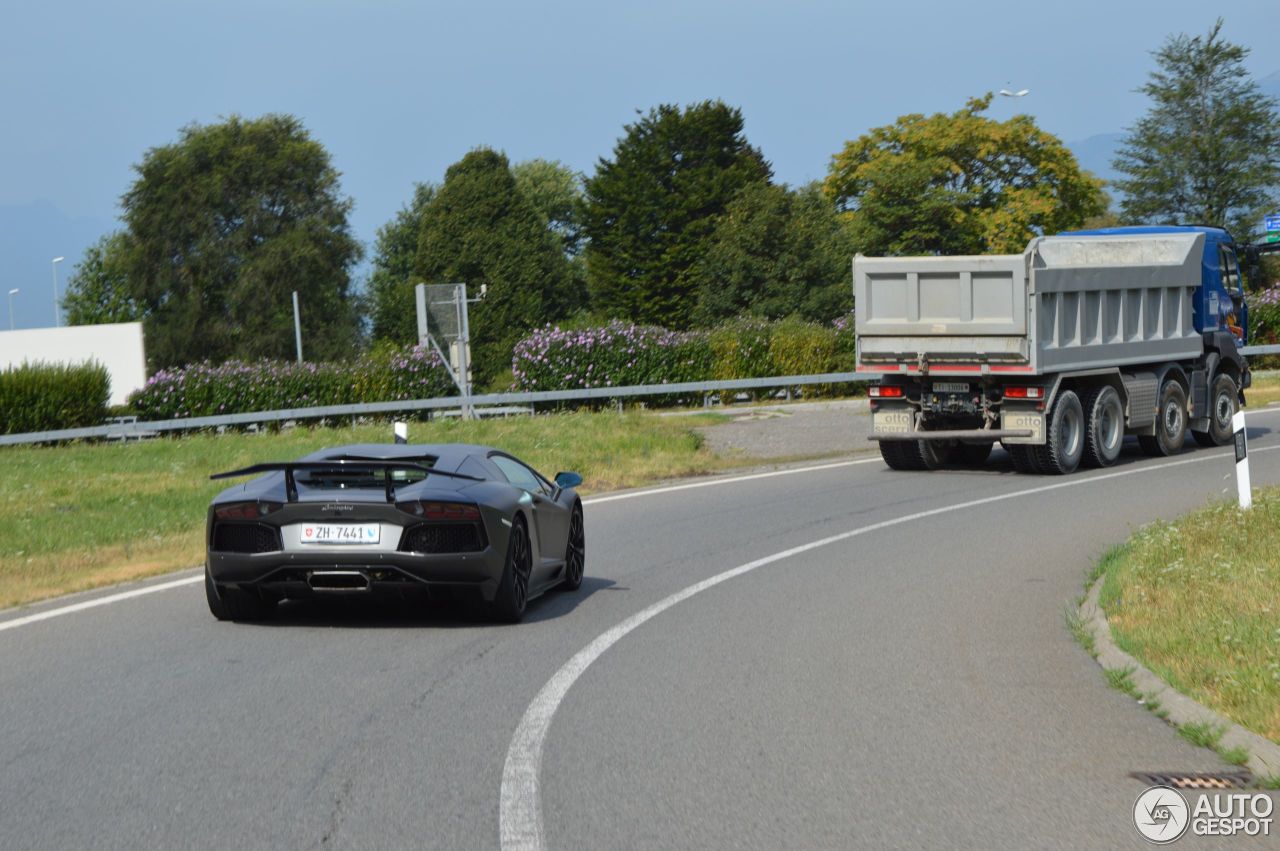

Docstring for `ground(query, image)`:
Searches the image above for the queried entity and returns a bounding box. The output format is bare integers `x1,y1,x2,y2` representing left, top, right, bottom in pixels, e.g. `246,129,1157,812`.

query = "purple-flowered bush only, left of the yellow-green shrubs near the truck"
511,320,712,390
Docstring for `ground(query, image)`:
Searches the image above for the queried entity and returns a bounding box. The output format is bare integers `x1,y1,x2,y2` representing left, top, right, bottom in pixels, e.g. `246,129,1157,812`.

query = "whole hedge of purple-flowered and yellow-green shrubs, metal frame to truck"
511,317,854,394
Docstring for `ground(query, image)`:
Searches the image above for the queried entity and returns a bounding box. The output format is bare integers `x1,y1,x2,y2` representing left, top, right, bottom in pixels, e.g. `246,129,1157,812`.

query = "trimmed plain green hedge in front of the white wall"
0,362,111,434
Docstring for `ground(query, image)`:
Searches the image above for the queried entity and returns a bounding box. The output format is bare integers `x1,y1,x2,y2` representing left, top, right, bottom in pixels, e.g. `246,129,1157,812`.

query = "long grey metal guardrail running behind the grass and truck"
0,346,1280,447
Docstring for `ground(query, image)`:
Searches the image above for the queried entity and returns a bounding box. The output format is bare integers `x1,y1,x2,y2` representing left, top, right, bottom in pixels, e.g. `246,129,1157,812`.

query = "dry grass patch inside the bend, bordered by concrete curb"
1101,489,1280,742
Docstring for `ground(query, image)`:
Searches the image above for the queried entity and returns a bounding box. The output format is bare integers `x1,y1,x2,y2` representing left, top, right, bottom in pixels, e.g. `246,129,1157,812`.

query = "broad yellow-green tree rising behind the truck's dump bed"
823,93,1105,255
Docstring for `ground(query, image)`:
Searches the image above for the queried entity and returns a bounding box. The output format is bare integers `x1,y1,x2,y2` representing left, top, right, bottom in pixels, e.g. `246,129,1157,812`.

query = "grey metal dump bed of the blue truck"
854,233,1204,372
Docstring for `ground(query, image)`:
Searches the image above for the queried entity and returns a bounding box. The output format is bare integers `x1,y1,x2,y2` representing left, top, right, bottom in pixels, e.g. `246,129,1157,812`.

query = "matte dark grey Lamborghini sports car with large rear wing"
205,444,586,622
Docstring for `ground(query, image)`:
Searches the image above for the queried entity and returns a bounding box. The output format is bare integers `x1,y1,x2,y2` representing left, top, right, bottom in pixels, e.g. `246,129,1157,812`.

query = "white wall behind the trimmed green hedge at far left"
0,322,147,404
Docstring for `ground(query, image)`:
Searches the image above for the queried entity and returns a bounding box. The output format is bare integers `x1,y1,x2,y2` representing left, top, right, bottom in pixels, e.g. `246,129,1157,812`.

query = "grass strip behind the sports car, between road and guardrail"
0,412,744,608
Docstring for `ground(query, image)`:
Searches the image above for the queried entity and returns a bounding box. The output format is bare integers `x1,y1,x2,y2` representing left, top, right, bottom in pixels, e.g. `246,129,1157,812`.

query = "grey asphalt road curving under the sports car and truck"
0,412,1280,848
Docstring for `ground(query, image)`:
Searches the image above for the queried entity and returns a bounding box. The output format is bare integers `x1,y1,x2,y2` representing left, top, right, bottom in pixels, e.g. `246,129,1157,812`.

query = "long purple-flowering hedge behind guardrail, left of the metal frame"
129,347,457,420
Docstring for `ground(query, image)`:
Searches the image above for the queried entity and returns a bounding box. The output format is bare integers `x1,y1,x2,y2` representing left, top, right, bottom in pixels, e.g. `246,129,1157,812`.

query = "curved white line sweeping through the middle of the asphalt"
498,447,1280,851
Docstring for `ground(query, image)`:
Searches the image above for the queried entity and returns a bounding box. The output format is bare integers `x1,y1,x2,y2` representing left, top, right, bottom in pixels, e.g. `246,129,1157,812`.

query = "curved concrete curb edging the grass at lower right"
1079,576,1280,778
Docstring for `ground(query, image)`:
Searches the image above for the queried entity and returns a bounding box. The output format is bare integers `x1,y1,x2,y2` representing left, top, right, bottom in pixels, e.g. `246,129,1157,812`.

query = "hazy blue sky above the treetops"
0,0,1280,328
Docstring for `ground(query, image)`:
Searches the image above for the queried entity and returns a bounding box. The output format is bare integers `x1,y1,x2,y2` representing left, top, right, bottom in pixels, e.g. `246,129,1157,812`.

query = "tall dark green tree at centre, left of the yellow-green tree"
582,101,771,328
